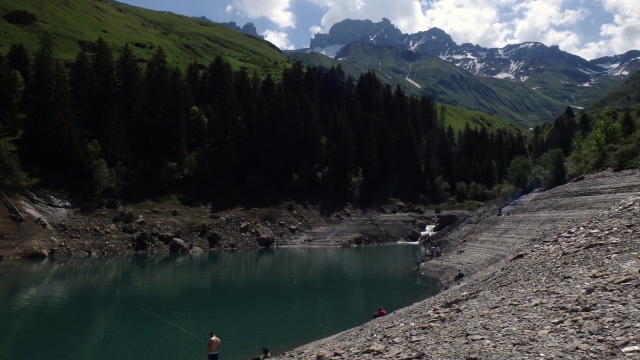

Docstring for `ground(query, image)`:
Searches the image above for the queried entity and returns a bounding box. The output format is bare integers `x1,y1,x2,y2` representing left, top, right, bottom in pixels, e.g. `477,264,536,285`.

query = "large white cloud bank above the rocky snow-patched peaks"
306,0,640,59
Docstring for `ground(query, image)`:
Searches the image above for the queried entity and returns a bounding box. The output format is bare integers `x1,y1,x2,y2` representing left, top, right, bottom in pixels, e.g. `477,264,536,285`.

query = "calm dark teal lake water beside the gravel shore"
0,244,439,360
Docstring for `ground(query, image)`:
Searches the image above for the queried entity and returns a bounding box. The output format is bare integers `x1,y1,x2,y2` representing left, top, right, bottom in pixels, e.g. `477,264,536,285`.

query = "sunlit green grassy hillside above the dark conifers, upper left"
0,0,288,74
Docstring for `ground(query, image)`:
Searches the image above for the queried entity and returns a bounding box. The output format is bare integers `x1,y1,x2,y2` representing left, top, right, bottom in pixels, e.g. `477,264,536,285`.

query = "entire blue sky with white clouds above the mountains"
120,0,640,60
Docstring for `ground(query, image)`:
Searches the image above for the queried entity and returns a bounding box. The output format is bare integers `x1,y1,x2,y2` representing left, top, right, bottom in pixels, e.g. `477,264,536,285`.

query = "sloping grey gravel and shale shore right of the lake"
278,170,640,359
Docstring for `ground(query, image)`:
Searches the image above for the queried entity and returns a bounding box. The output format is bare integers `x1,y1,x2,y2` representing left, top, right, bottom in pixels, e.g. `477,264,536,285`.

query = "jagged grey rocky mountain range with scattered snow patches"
302,18,640,84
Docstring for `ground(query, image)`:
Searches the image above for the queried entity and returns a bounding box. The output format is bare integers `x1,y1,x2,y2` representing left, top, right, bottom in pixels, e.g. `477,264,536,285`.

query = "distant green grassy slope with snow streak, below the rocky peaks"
287,43,566,127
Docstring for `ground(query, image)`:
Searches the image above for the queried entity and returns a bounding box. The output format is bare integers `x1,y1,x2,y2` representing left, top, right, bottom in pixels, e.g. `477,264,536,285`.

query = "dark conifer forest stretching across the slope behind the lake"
0,35,638,207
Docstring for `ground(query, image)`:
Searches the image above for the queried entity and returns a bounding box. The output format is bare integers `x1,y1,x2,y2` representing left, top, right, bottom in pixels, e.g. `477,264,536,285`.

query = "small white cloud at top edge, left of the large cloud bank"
226,0,296,28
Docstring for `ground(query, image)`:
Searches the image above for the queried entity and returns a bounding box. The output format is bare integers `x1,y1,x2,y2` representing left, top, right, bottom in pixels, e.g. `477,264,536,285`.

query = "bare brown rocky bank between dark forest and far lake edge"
0,194,442,259
